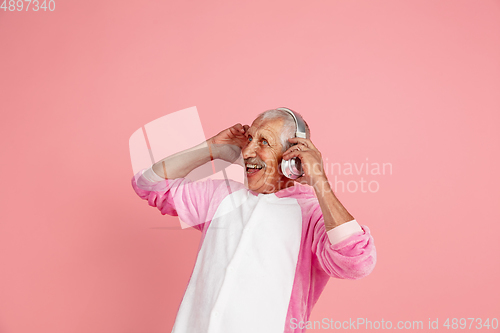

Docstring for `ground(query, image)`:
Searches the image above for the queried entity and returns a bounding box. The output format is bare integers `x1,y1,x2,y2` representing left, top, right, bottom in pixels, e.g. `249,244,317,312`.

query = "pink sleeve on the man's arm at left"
132,170,237,230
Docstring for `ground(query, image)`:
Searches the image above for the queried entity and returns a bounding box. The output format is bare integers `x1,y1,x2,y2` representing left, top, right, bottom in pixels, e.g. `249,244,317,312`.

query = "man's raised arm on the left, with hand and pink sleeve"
132,124,248,230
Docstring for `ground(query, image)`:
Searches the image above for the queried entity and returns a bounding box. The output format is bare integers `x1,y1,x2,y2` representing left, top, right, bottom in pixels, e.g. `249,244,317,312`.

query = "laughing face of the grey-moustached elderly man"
242,118,286,193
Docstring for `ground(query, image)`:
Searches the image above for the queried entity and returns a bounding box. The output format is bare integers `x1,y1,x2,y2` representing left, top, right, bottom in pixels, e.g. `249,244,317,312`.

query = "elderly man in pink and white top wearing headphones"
132,108,376,333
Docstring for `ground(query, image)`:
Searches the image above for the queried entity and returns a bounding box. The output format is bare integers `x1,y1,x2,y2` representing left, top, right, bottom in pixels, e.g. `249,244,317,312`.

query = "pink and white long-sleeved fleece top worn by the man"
132,167,376,333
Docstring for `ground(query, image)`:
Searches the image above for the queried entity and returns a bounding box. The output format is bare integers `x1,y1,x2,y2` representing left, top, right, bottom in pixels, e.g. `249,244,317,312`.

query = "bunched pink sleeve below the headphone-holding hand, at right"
311,205,377,280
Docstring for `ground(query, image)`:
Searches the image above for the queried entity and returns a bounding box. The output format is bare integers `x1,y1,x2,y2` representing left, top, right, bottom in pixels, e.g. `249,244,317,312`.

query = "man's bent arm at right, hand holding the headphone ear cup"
283,138,377,279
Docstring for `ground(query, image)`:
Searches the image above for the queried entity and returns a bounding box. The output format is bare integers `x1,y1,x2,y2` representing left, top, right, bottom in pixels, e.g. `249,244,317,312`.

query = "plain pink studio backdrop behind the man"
0,0,500,333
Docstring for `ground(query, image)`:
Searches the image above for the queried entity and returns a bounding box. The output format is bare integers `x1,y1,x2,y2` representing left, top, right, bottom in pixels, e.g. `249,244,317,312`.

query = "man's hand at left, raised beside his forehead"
207,123,250,163
